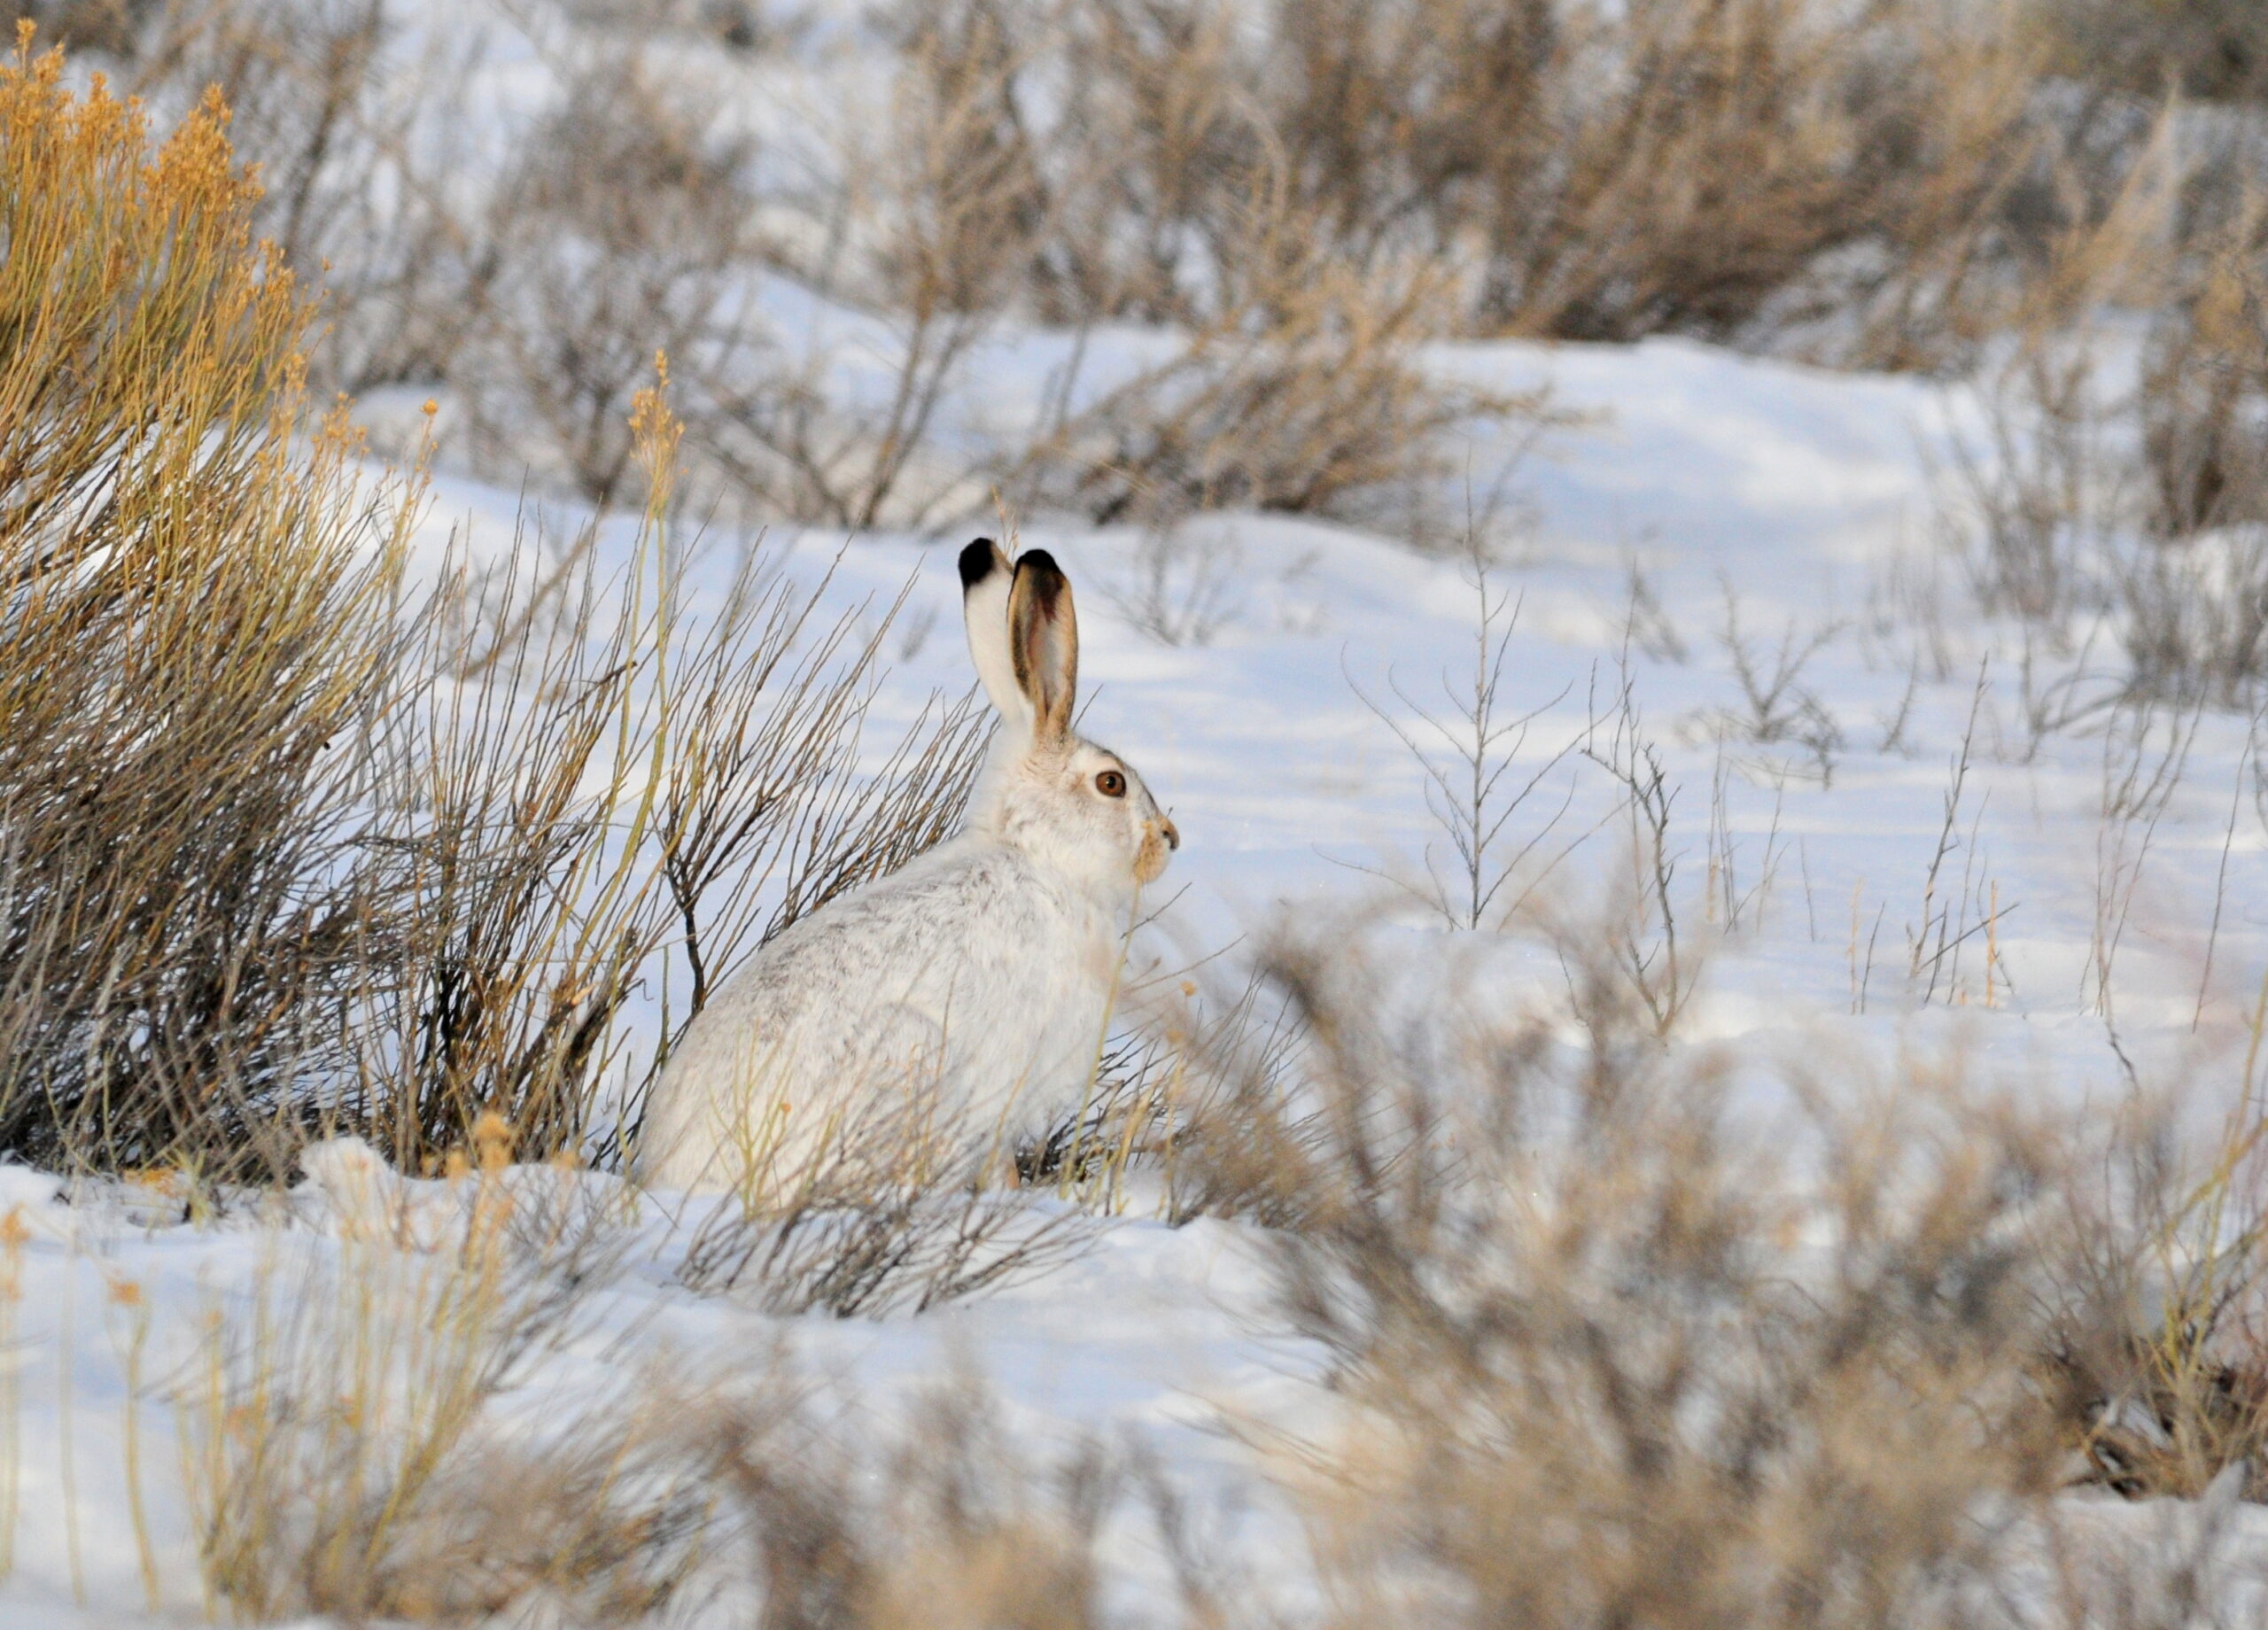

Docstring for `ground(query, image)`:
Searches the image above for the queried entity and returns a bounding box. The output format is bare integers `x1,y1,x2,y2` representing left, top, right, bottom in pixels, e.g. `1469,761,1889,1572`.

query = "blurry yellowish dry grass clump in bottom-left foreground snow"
177,1120,714,1623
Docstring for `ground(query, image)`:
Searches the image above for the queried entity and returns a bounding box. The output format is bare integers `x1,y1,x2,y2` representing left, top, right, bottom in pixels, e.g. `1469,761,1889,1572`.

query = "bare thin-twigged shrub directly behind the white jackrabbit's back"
331,415,984,1170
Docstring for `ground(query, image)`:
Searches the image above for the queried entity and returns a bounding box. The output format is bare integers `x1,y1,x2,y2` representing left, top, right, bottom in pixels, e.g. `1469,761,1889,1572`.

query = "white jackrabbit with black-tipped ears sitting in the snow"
637,538,1182,1199
